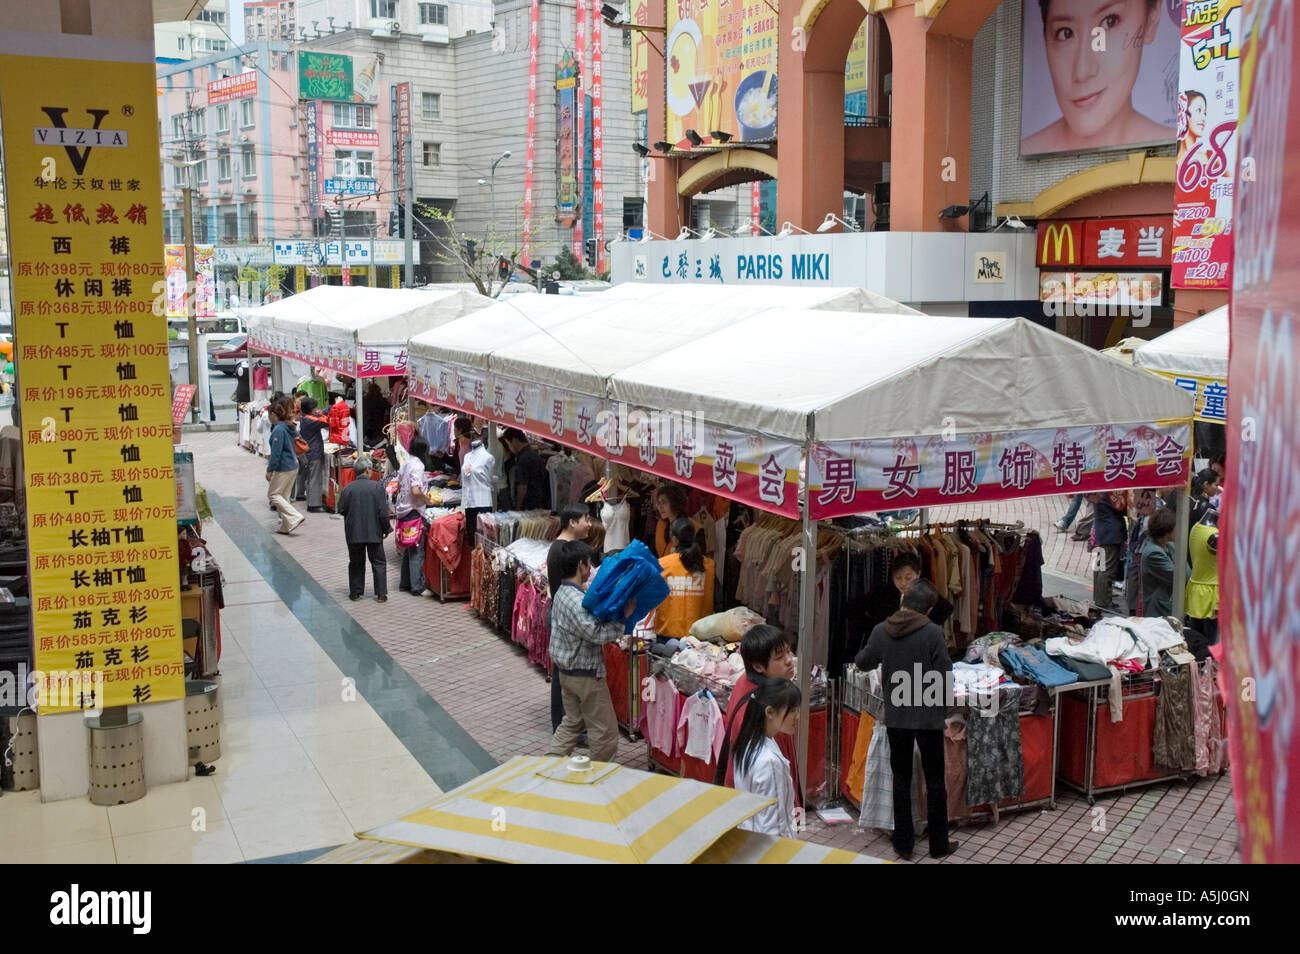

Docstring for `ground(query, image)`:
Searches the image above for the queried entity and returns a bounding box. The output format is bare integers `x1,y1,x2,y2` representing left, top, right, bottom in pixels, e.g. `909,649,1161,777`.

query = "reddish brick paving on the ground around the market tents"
186,433,1240,864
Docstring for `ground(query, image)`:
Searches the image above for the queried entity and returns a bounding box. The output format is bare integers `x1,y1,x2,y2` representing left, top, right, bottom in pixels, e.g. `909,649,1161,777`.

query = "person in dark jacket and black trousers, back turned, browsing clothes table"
853,580,957,859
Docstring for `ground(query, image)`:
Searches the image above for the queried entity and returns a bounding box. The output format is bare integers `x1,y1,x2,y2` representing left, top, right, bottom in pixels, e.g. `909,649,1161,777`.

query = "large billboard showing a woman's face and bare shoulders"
1021,0,1180,156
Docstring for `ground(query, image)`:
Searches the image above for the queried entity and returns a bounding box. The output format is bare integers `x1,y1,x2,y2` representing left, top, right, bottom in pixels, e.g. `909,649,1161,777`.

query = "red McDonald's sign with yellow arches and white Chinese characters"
1035,216,1174,268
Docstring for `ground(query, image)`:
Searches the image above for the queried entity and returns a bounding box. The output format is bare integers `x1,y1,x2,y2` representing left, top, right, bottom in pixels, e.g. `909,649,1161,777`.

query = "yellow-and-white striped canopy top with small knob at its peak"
358,755,772,864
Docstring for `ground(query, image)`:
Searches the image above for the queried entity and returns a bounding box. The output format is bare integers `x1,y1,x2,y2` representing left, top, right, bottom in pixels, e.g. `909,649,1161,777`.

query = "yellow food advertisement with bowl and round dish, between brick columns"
665,0,780,143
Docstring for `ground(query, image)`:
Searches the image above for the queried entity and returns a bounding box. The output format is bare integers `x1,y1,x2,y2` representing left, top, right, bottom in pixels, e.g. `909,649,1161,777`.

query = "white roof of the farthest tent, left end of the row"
248,285,490,344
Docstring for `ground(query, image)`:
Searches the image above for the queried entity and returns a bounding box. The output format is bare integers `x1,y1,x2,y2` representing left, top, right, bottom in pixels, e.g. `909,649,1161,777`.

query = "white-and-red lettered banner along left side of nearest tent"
618,406,801,517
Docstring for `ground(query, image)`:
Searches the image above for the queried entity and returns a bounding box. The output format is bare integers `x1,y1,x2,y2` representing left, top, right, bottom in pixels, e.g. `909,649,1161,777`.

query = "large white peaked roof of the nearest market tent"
608,317,1192,442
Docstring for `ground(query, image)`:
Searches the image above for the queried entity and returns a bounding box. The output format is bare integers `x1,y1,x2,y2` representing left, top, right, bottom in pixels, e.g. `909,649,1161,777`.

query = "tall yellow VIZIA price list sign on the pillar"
0,56,185,714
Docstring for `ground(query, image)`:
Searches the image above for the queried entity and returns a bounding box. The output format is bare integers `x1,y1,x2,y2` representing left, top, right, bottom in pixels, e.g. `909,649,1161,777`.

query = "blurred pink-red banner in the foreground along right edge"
1214,0,1300,864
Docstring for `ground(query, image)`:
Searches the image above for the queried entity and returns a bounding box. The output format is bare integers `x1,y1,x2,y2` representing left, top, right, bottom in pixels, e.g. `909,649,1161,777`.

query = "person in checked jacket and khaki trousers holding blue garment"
546,541,637,762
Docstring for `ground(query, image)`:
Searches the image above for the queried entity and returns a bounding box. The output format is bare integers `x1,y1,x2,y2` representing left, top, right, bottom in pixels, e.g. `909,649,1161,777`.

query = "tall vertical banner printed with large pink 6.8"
1170,0,1242,289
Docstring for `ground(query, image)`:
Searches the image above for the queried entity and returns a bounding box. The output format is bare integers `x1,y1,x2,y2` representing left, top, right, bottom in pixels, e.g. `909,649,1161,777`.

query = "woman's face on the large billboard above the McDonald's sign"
1043,0,1160,135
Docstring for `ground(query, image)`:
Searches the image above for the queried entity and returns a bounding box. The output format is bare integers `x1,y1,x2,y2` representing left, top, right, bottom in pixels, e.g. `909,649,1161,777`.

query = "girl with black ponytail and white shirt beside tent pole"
732,680,801,838
